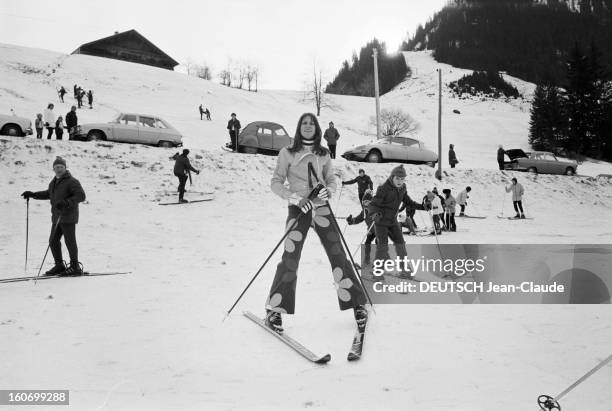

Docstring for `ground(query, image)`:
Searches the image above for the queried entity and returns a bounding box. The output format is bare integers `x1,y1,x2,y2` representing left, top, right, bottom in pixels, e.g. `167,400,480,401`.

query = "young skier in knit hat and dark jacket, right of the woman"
368,166,423,278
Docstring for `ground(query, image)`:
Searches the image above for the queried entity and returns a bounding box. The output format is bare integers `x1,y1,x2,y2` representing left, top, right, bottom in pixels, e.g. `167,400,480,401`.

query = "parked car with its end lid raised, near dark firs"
504,149,578,176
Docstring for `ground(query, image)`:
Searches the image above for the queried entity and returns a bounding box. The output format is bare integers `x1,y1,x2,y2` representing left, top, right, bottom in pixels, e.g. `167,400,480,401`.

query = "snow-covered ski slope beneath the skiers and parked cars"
0,45,612,411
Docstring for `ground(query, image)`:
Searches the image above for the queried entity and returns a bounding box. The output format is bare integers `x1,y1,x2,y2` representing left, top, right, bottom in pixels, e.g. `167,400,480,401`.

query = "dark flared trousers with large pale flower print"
266,205,366,314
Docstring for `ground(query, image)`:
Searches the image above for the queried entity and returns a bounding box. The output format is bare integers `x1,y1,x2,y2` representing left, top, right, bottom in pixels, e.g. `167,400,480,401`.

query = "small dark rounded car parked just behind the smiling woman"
238,121,293,154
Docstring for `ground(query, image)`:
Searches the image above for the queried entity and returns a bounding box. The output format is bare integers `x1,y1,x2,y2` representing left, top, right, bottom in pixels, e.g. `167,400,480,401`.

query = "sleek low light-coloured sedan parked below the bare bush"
342,137,438,165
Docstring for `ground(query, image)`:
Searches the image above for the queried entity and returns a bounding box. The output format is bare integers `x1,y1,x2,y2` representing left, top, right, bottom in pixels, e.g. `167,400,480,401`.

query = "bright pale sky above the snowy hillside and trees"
0,0,447,89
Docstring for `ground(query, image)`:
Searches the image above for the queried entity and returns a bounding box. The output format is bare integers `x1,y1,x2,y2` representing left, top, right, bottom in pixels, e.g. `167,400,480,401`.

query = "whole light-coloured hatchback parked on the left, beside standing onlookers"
73,113,183,147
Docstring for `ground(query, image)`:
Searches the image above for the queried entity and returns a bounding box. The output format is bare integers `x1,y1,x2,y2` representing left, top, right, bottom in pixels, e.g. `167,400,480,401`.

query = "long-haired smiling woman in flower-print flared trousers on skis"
265,113,368,333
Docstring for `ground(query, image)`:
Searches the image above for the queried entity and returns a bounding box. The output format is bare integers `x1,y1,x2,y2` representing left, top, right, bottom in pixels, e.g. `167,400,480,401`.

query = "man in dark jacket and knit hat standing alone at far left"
22,157,85,276
